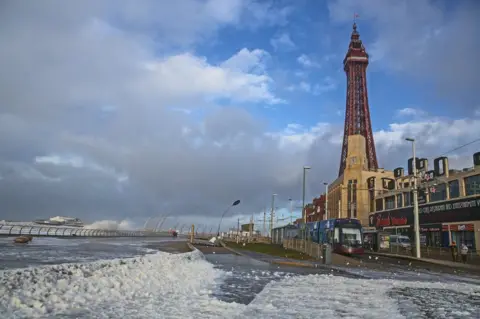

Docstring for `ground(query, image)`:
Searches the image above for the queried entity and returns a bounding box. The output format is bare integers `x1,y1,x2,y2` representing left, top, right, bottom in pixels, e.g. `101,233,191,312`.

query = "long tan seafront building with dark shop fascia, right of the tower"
369,152,480,250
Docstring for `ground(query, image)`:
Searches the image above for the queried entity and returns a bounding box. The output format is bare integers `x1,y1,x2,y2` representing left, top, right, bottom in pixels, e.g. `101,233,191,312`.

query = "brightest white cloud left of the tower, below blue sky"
144,49,281,103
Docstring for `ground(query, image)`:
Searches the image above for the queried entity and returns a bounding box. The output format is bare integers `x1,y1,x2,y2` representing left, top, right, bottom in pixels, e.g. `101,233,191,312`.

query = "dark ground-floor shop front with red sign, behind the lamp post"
369,196,480,249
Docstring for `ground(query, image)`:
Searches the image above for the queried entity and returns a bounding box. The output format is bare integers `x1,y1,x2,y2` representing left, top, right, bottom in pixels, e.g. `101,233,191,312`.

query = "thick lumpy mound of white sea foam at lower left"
0,252,240,318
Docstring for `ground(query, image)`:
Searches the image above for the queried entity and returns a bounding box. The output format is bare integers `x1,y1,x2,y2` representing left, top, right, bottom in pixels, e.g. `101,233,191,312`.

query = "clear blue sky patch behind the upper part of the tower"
190,1,475,130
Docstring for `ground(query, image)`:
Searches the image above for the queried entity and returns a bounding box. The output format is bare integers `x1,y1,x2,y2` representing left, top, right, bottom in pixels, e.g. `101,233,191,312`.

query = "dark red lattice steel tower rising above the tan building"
338,23,378,176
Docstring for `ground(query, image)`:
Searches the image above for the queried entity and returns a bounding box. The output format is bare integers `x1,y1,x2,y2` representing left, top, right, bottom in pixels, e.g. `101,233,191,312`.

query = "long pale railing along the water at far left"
0,224,171,237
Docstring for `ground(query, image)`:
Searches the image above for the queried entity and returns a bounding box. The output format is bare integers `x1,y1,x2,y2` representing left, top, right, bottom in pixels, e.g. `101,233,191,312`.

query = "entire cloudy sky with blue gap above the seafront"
0,0,480,230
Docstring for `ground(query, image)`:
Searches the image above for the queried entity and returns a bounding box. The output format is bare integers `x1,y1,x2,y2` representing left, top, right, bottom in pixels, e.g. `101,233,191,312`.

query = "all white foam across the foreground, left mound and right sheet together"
0,251,480,319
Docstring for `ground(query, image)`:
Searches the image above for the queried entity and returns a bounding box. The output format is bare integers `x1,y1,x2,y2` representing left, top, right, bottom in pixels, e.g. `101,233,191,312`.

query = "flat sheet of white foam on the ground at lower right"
242,275,480,319
